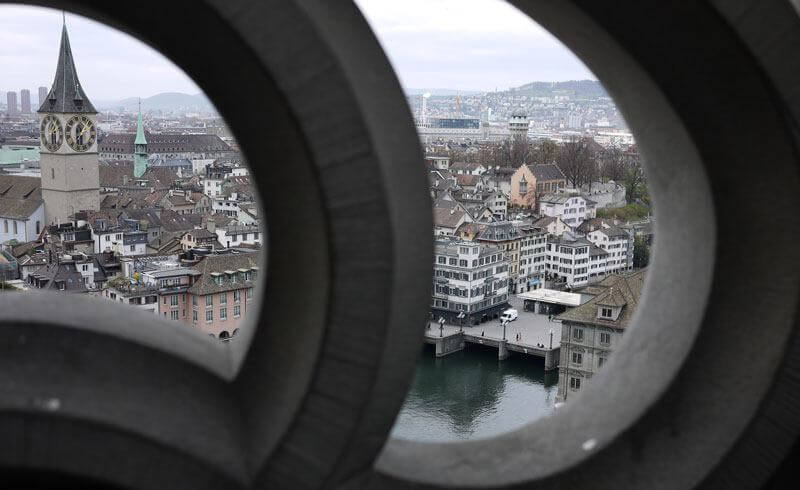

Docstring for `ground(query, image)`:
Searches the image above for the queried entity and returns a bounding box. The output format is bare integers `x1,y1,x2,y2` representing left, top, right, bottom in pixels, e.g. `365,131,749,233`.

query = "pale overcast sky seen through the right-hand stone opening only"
356,0,597,90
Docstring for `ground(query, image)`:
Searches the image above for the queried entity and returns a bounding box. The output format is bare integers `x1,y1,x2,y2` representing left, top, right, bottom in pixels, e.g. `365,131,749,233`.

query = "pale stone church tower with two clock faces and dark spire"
37,23,100,223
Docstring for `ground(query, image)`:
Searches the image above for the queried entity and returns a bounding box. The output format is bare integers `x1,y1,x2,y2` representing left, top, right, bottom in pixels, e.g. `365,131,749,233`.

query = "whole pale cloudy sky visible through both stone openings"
0,0,595,100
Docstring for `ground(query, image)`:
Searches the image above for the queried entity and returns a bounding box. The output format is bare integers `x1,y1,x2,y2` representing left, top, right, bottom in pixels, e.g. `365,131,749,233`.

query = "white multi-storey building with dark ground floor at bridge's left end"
431,239,509,325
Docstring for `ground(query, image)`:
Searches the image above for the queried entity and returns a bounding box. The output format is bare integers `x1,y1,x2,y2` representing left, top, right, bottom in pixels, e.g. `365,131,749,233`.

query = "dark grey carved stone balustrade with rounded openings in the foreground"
0,0,800,489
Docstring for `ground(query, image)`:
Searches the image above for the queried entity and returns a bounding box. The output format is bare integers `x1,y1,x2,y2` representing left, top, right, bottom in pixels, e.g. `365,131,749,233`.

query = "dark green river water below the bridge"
392,344,558,441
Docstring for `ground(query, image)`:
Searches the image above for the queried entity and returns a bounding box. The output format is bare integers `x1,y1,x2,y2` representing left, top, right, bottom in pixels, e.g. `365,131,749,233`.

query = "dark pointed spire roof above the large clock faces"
38,24,97,114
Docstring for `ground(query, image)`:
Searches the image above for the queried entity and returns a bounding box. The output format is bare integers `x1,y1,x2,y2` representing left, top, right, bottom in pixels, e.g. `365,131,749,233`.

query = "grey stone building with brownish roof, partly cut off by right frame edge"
556,270,646,402
